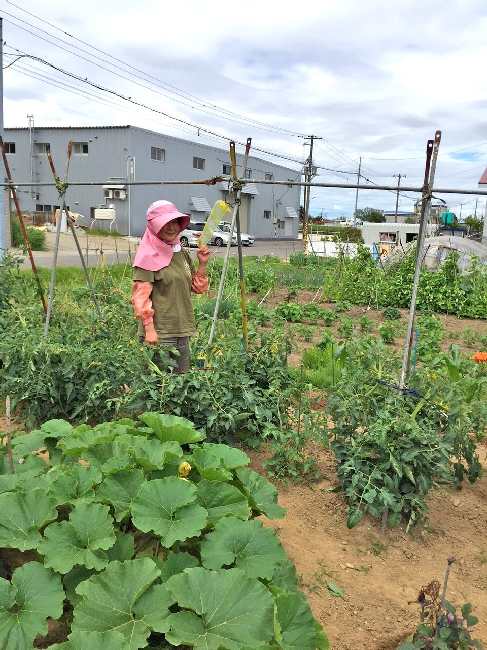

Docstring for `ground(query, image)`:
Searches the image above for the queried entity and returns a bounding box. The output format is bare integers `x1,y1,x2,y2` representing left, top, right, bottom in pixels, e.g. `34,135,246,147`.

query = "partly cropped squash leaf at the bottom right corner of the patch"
275,594,316,650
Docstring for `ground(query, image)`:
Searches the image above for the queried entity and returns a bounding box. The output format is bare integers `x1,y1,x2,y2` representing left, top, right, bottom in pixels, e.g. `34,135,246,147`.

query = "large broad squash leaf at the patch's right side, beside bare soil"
201,517,286,580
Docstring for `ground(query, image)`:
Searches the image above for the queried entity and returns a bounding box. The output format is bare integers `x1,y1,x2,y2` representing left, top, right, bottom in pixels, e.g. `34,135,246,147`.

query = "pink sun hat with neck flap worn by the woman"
133,201,190,271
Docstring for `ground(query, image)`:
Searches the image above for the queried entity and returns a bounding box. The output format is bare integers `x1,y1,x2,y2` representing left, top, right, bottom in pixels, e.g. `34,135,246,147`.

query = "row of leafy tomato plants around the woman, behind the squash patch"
0,262,291,444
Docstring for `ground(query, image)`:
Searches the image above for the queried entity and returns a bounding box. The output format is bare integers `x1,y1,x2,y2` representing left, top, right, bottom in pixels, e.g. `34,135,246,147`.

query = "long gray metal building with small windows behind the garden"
4,124,300,239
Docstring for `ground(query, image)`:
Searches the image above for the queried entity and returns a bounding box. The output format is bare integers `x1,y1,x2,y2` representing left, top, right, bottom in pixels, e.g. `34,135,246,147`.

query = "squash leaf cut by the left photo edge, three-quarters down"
0,489,58,551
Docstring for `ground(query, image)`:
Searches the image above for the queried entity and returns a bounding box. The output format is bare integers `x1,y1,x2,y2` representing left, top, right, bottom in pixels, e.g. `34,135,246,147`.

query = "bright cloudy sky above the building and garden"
0,0,487,218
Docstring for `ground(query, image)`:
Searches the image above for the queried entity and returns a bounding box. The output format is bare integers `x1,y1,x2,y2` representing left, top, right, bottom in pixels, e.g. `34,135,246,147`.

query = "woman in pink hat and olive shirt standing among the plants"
132,201,210,373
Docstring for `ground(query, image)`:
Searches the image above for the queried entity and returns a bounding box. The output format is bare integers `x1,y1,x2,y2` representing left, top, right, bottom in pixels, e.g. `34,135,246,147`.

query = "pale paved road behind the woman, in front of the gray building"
15,232,302,269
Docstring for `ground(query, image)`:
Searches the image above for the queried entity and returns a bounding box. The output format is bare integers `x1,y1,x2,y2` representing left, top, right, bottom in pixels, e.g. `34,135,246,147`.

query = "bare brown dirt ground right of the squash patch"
252,446,487,650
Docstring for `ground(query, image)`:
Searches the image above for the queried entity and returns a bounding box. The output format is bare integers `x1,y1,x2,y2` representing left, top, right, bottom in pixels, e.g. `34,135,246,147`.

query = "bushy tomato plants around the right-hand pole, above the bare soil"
327,337,487,528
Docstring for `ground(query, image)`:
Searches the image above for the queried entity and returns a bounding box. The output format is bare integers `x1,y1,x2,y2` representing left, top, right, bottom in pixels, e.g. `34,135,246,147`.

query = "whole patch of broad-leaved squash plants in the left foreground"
0,413,328,650
